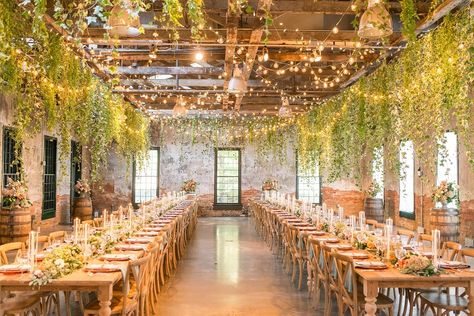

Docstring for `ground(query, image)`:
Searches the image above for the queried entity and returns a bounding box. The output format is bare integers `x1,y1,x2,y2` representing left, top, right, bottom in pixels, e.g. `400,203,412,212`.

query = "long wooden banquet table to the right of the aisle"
253,201,474,316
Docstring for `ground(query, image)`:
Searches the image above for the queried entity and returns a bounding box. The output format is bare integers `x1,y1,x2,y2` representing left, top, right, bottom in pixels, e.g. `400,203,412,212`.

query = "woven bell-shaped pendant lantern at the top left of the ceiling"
107,0,141,37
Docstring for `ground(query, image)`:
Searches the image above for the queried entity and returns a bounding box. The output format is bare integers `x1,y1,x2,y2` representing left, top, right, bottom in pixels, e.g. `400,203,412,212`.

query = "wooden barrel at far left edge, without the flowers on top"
0,207,31,244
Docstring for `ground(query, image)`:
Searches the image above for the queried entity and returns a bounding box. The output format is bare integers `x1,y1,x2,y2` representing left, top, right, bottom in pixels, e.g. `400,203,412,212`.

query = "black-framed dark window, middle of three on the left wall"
41,136,58,220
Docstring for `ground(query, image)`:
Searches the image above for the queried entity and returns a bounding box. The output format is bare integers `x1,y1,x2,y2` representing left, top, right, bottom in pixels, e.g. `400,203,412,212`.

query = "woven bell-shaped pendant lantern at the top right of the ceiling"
357,0,393,40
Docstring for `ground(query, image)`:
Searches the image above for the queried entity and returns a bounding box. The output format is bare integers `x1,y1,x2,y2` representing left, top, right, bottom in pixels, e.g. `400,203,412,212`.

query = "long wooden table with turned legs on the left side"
0,202,196,316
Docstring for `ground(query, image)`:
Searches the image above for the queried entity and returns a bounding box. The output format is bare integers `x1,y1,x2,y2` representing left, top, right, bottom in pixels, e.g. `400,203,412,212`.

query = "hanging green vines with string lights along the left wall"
0,0,148,179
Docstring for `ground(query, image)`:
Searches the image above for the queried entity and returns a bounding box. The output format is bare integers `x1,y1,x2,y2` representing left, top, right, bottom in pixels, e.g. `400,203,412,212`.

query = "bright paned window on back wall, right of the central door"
296,155,321,204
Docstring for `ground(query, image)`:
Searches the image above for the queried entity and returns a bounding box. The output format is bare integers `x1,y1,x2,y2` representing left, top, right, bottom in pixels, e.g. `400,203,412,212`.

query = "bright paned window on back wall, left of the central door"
133,148,160,204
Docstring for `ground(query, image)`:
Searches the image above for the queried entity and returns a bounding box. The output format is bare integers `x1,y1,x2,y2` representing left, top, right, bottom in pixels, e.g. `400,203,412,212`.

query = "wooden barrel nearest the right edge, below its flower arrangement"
430,208,459,242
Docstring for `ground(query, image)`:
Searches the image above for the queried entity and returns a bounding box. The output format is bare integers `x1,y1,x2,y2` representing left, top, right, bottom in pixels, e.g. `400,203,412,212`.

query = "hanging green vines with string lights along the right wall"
297,10,474,180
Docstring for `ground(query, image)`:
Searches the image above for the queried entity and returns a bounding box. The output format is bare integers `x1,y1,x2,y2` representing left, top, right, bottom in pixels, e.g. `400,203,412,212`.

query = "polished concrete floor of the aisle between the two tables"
159,217,316,316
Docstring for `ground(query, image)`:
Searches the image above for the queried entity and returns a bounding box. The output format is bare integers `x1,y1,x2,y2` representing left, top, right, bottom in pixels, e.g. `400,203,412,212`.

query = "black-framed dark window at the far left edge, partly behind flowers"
2,127,21,187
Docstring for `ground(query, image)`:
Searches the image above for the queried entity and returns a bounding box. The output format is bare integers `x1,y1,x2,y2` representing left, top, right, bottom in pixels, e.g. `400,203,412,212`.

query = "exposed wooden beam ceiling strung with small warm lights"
60,0,467,114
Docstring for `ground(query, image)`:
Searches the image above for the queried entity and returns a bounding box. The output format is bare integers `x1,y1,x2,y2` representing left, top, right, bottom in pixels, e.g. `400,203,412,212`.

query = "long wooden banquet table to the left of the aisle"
0,201,197,316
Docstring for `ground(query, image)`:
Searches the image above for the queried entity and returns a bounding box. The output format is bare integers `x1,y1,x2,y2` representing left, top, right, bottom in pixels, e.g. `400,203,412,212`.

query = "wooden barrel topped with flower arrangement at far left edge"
0,178,32,244
